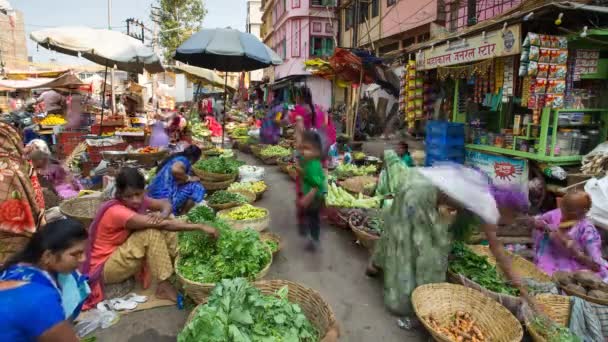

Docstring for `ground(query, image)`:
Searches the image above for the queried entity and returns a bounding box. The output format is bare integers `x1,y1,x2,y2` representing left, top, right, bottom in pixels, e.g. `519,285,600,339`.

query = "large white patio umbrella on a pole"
30,27,164,132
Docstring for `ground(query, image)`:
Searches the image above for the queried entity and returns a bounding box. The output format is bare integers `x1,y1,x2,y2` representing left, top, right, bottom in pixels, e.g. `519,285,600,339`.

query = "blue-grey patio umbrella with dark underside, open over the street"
174,28,283,145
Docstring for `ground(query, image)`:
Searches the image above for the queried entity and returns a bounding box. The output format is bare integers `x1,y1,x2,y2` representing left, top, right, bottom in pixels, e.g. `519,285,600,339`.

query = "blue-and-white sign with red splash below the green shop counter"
465,150,528,194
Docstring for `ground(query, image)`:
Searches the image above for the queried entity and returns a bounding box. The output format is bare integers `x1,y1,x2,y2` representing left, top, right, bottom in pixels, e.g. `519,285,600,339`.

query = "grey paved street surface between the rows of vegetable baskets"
97,155,425,342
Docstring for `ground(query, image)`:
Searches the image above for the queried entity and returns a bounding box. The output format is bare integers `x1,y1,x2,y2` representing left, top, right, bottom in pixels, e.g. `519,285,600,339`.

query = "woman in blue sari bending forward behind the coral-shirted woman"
148,145,205,215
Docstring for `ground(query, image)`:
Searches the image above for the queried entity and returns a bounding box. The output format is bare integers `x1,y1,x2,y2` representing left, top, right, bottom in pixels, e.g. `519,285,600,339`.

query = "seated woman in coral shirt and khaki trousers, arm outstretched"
83,168,218,308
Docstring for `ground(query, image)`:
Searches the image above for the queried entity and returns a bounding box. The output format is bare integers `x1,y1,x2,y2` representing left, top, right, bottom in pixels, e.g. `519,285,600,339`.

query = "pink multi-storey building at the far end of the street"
262,0,338,108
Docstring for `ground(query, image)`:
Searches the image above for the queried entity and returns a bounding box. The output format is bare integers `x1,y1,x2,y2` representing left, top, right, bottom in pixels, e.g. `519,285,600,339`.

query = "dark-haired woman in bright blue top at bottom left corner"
0,219,87,342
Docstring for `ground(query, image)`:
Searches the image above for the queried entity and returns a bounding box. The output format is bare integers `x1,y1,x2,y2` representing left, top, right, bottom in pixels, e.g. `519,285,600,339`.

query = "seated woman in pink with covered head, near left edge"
30,150,83,199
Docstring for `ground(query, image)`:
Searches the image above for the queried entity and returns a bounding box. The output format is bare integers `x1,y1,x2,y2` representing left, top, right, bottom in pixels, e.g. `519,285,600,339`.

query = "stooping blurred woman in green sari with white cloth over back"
367,151,525,316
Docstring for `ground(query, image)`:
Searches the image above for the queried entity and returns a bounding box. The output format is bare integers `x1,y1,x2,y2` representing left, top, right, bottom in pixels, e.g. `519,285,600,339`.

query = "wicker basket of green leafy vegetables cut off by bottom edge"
177,278,339,342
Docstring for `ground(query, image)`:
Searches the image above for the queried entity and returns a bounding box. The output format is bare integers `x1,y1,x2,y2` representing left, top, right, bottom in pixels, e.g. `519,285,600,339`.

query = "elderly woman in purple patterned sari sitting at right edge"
533,191,608,281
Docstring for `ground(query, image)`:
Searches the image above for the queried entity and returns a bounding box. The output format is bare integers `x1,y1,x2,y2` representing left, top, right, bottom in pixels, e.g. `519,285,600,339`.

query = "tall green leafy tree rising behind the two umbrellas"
153,0,207,62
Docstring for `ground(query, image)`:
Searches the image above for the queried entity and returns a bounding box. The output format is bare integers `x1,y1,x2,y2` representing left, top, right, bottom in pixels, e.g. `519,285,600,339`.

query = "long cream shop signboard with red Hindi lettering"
416,24,521,70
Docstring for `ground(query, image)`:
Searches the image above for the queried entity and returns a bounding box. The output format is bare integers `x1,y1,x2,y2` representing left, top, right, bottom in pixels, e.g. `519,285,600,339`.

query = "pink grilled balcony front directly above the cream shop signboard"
444,0,522,32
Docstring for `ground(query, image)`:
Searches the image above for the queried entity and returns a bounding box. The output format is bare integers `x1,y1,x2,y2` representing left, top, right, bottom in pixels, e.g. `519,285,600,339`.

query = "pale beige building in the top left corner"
0,11,28,71
